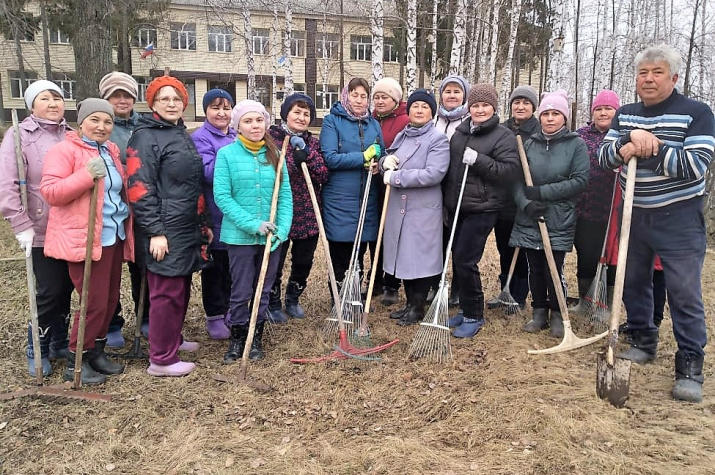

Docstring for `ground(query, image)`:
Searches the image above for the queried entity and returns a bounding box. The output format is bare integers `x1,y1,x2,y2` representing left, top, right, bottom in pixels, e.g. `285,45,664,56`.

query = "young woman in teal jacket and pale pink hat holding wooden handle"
214,100,293,363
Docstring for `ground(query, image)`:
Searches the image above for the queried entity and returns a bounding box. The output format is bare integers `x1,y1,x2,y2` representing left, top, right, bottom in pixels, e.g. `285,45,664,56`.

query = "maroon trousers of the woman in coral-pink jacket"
67,244,124,351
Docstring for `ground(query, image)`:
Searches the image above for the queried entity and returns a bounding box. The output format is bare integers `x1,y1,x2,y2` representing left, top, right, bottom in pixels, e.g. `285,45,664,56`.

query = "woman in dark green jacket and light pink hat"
509,90,589,338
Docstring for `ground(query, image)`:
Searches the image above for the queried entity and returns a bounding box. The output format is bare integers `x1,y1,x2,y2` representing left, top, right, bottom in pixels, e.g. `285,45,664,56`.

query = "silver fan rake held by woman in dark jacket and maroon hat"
408,165,469,363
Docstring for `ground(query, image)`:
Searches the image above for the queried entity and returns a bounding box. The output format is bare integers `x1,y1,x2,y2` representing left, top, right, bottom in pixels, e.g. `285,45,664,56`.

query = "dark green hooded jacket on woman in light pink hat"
509,128,589,252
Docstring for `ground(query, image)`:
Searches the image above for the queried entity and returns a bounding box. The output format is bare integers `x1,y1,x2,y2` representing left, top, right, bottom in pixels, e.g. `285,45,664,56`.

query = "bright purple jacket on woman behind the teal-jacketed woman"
191,120,237,249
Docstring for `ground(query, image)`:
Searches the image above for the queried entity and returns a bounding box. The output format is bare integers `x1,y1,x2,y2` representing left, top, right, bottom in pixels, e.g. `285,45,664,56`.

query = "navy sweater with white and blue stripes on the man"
599,90,715,208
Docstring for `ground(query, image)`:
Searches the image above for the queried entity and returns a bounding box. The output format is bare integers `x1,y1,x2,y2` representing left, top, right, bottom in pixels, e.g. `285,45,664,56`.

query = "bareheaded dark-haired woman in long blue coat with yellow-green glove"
320,78,385,290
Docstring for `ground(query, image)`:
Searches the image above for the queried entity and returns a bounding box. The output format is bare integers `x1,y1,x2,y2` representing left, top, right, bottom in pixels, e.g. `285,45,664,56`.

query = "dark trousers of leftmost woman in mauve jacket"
27,247,74,358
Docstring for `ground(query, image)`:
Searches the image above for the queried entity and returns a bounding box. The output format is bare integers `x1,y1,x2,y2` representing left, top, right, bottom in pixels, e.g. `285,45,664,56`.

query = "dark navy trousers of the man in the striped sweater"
623,198,707,356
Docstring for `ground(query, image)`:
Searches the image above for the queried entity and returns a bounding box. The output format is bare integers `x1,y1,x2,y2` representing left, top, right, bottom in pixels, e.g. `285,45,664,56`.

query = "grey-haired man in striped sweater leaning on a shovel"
599,45,715,402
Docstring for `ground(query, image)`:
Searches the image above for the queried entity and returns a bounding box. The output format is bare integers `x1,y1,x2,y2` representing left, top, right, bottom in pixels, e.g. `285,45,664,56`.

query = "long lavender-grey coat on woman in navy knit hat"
383,122,449,279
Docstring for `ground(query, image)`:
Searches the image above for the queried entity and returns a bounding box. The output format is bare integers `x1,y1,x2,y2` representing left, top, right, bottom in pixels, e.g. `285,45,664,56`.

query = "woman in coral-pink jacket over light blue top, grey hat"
40,98,134,384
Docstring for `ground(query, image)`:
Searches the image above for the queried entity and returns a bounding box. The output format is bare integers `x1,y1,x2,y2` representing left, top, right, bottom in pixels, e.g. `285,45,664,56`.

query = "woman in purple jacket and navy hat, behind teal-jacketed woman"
191,88,236,340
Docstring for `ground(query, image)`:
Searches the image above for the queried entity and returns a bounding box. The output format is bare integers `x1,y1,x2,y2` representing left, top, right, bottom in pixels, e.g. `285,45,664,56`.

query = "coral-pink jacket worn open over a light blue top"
40,131,134,262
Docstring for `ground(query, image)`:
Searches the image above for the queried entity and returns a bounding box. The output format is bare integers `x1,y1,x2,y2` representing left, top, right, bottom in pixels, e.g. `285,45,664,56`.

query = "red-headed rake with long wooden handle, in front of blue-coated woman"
290,163,399,364
